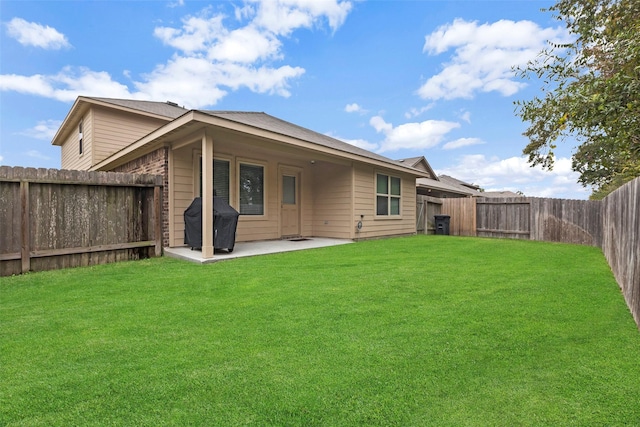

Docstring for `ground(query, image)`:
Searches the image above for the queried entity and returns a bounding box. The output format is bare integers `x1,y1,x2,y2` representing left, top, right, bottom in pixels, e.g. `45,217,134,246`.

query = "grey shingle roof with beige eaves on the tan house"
62,97,430,177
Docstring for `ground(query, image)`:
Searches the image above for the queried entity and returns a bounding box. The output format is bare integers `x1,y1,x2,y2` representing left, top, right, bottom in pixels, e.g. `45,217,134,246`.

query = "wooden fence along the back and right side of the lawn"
442,178,640,326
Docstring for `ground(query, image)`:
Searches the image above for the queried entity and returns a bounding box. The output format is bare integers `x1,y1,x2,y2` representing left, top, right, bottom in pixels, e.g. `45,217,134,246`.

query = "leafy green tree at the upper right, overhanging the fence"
516,0,640,198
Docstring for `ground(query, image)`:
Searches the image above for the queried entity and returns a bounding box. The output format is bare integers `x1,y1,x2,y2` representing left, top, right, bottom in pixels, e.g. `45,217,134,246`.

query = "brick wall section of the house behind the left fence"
113,147,169,248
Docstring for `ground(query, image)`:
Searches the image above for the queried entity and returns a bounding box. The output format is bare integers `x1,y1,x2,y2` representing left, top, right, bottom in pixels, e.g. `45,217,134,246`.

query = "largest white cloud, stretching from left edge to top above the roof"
0,0,351,108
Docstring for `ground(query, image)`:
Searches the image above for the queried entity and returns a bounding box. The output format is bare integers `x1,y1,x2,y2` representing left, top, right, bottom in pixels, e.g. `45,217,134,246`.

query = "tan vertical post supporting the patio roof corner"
202,131,214,259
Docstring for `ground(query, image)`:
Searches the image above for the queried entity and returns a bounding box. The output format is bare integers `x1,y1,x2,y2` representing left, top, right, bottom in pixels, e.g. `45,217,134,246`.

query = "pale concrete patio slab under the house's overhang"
164,237,354,264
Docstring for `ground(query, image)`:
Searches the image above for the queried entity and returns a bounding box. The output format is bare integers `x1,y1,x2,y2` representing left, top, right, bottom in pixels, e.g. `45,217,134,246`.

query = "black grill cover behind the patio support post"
184,197,240,252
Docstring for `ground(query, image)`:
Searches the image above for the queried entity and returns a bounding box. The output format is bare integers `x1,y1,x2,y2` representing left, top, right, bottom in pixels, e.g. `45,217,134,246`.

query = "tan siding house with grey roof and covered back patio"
52,97,429,258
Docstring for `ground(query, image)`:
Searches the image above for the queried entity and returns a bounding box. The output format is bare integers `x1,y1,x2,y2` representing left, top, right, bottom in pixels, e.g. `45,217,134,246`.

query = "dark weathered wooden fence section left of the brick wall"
0,166,162,276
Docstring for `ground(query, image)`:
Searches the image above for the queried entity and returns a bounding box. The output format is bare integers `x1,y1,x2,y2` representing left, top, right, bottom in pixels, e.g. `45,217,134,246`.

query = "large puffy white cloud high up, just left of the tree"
418,19,569,100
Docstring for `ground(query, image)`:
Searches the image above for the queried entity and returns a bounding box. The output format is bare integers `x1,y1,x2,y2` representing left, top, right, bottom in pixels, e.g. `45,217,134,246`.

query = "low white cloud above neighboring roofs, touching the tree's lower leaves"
436,154,590,199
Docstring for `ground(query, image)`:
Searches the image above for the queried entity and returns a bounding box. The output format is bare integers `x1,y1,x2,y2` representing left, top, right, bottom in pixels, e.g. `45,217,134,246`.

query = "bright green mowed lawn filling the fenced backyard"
0,236,640,426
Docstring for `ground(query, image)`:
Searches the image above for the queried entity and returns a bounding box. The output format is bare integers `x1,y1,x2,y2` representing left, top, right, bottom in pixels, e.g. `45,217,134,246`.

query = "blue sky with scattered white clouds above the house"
0,0,591,199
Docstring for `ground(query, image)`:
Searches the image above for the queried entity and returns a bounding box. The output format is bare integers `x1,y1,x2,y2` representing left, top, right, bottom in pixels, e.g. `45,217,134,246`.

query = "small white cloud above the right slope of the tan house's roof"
369,116,460,153
